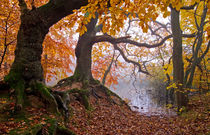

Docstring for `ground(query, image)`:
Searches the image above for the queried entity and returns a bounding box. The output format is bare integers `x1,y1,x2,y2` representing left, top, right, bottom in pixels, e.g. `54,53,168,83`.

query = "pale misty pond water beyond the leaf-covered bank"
113,78,176,116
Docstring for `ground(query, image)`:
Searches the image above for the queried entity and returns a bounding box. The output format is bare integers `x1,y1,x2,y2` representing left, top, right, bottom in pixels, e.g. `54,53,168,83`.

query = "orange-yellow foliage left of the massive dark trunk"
0,0,20,79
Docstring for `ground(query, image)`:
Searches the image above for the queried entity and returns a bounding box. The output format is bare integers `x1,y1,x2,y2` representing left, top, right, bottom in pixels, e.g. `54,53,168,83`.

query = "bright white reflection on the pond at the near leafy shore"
129,90,176,116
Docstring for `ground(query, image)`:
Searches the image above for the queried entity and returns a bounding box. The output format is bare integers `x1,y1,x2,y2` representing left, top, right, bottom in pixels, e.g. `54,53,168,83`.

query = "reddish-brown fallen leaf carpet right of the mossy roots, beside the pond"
65,91,210,135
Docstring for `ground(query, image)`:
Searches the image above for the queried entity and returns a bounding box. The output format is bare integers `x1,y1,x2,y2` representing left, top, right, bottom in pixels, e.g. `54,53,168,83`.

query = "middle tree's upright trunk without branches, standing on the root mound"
74,17,97,81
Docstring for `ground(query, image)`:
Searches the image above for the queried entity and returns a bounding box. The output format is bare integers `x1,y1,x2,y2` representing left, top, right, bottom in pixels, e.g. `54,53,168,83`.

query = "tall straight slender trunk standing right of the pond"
171,8,188,110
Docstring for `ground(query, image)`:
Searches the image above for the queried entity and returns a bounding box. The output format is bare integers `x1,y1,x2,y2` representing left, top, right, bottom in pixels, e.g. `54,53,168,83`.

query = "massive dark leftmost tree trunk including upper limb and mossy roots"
5,0,88,110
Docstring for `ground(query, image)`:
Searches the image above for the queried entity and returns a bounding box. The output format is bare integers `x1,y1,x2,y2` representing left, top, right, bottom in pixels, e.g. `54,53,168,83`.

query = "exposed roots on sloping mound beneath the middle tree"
54,75,129,110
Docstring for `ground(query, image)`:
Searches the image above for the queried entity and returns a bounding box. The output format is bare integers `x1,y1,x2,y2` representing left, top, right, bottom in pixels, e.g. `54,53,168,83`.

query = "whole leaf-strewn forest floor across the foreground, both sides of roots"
0,87,210,135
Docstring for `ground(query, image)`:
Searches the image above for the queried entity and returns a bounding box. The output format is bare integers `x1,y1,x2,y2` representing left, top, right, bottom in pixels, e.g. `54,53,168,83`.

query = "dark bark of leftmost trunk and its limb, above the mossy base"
6,0,88,85
